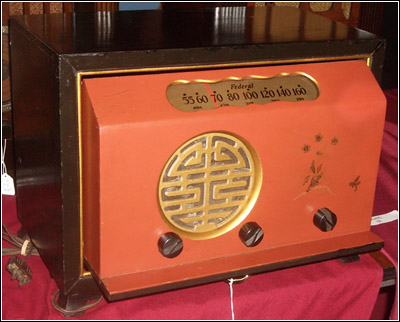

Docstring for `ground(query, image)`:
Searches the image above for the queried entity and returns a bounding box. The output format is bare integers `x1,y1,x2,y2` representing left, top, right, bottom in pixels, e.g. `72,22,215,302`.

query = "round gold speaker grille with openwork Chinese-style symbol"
158,132,262,239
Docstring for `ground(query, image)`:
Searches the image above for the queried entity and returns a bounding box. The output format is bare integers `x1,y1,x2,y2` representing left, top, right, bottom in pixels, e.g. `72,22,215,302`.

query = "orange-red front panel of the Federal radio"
81,61,386,299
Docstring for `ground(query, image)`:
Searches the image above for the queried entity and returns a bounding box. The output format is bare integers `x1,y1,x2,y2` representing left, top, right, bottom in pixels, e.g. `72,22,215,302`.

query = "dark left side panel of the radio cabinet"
10,22,64,291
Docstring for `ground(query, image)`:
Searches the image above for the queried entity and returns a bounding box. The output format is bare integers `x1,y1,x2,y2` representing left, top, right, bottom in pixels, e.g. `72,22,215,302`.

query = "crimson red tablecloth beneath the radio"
2,90,398,320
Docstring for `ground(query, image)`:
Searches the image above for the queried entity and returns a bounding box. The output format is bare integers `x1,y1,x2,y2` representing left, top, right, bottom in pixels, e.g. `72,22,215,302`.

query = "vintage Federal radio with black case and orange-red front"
10,7,386,311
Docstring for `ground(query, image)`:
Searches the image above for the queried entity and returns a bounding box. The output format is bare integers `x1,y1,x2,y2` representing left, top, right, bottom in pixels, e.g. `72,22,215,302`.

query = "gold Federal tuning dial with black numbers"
167,73,319,112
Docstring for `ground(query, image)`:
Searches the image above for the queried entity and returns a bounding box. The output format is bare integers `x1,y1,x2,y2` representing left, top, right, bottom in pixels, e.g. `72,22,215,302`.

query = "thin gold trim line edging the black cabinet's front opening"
76,54,372,277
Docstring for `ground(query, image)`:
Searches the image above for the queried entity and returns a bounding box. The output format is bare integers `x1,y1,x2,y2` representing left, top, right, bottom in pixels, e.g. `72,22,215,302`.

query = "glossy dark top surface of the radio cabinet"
7,7,380,54
